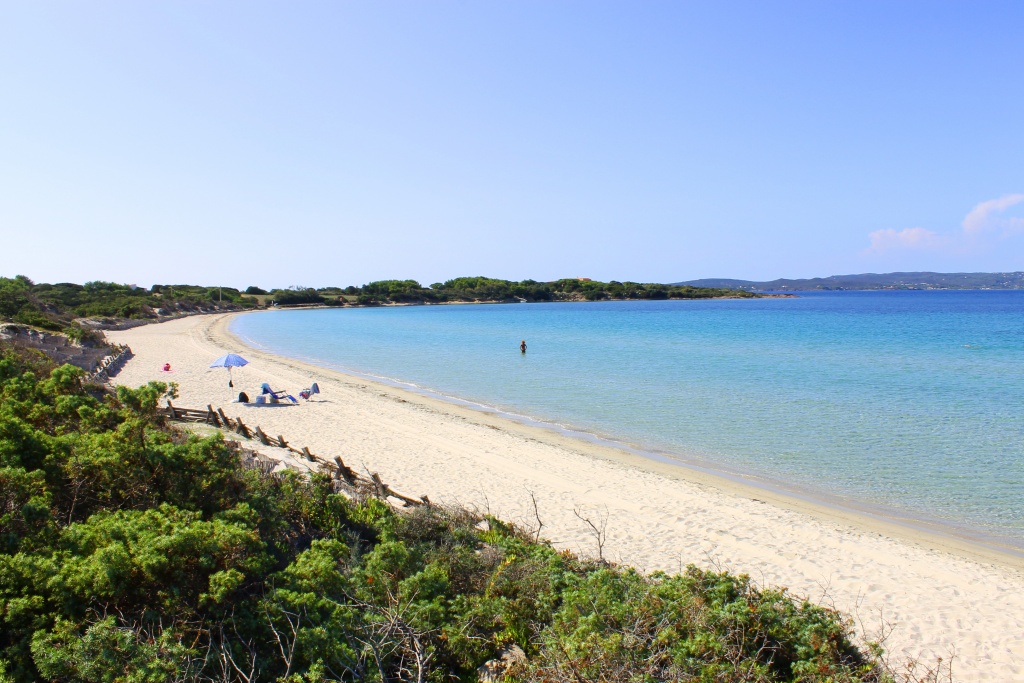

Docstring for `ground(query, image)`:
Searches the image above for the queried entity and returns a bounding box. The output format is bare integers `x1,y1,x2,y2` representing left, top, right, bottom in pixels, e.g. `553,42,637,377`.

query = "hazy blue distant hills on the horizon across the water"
673,271,1024,292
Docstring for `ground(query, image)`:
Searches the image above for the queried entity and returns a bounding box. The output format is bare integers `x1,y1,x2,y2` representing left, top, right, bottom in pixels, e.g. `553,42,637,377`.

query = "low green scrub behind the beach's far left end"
0,275,255,334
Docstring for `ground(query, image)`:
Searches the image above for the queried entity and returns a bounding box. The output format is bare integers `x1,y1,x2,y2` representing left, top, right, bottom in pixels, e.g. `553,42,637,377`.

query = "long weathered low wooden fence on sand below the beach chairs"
165,400,430,506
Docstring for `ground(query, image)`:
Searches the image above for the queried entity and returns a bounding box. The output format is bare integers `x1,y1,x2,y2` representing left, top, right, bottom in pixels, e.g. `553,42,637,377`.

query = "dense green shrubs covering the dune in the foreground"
0,348,879,683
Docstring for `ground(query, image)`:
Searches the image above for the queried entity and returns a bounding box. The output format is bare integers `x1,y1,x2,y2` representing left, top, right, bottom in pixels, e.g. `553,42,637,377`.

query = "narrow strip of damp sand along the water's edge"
228,309,1024,571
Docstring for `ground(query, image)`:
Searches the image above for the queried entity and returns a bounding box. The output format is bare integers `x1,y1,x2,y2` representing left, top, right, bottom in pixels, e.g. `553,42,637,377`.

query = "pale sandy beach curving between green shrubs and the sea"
108,315,1024,681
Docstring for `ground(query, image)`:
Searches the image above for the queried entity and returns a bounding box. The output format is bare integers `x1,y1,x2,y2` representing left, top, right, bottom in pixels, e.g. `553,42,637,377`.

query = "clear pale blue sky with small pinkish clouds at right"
0,0,1024,288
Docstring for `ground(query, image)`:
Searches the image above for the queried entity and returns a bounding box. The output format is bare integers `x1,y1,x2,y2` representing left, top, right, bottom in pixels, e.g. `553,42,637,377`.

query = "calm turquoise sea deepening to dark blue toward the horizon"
232,291,1024,550
